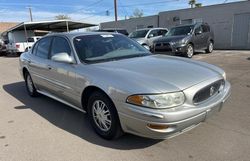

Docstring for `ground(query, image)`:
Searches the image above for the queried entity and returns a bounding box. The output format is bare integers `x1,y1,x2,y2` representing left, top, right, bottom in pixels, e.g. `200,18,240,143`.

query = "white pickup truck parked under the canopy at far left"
6,36,41,54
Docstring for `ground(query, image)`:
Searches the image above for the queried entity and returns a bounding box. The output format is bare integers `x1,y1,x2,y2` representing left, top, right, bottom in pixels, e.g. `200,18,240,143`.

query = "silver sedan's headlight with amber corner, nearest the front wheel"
127,92,185,109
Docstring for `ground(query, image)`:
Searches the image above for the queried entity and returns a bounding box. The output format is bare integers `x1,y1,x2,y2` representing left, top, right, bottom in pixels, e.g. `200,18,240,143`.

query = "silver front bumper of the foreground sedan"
118,82,231,139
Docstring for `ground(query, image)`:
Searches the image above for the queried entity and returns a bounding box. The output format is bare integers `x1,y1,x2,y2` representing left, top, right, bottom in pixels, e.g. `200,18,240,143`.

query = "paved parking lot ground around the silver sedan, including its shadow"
0,50,250,161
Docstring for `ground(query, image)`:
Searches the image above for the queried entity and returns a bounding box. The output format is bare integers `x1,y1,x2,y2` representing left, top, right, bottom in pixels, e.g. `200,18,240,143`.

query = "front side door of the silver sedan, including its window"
49,36,79,105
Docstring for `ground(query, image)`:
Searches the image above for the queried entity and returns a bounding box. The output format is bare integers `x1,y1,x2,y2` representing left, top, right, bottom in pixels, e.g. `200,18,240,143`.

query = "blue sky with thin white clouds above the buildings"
0,0,244,24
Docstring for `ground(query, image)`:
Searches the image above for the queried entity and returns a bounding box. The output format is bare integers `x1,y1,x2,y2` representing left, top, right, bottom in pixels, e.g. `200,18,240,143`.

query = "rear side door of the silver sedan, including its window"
28,37,52,91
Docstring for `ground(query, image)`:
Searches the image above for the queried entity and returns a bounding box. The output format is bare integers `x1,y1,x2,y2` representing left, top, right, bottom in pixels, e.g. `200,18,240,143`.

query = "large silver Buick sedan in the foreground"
20,33,231,139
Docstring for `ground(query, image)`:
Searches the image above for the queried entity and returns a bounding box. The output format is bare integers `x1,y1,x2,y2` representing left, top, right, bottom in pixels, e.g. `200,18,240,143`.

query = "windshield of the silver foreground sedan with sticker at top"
74,34,150,63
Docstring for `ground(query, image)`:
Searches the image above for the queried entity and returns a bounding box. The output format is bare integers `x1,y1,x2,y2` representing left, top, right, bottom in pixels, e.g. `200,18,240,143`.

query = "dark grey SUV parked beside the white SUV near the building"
152,23,214,58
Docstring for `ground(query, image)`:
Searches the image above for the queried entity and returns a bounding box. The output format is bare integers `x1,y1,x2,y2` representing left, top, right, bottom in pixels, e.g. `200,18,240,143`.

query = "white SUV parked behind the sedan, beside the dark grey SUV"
128,28,168,49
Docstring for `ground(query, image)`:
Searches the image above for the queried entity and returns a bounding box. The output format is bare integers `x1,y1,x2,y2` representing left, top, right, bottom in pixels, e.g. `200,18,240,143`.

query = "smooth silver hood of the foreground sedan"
91,55,220,92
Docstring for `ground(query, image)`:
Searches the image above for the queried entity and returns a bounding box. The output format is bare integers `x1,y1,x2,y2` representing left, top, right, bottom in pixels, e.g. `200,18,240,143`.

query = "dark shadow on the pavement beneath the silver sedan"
3,82,162,150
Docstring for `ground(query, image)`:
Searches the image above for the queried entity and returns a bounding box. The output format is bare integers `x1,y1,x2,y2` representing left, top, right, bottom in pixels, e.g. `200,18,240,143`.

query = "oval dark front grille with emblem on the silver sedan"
193,80,225,104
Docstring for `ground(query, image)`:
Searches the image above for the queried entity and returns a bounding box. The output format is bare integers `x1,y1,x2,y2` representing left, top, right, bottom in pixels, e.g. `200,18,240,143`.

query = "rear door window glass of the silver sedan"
36,37,52,59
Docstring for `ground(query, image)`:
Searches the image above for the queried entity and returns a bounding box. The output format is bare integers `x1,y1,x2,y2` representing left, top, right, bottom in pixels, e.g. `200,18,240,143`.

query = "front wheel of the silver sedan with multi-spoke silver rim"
88,92,123,140
